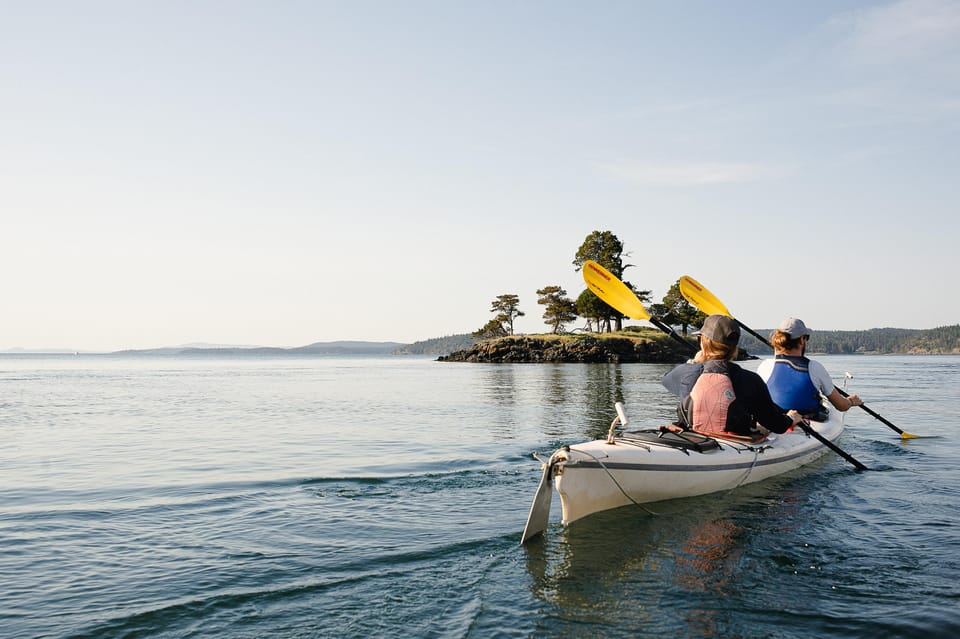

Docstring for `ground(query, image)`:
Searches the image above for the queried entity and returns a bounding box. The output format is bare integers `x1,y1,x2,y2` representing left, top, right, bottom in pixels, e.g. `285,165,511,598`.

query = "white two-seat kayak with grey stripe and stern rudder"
520,404,844,543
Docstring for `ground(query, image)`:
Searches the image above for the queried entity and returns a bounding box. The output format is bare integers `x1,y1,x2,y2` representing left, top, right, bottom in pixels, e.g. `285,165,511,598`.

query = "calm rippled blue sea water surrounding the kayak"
0,356,960,639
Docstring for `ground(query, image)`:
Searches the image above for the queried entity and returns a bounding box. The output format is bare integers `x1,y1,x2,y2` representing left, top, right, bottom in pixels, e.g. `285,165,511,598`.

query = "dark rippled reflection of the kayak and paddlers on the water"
527,480,816,637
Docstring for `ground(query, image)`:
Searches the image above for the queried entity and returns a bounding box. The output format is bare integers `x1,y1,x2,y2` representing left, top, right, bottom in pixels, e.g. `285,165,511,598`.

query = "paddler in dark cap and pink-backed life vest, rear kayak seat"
662,315,803,438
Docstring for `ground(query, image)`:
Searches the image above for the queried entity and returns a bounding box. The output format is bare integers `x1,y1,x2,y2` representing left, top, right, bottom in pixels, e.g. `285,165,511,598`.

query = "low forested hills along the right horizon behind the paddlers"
740,324,960,355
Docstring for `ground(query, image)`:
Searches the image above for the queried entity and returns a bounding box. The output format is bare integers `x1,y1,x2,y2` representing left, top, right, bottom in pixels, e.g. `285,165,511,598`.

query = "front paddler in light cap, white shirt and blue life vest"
757,317,863,421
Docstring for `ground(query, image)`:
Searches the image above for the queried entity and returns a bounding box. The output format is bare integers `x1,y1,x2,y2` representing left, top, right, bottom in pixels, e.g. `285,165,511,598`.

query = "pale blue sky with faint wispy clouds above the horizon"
0,0,960,351
